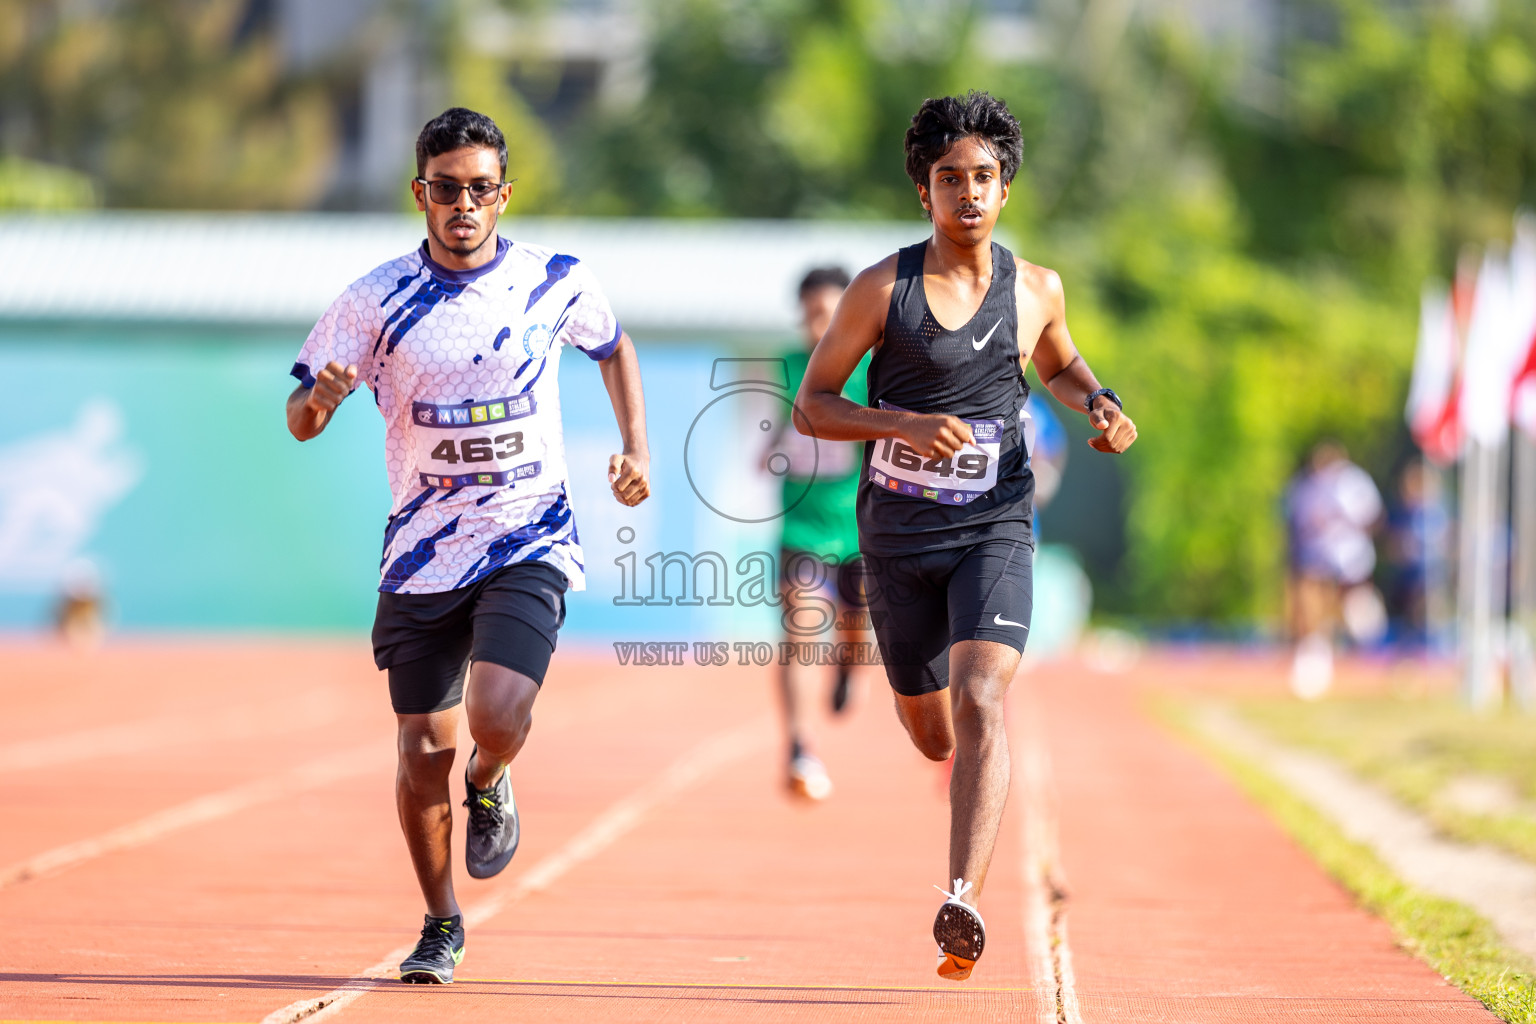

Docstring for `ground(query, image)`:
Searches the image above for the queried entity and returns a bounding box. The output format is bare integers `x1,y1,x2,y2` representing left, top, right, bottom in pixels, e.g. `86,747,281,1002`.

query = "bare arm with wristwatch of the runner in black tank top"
1018,259,1137,454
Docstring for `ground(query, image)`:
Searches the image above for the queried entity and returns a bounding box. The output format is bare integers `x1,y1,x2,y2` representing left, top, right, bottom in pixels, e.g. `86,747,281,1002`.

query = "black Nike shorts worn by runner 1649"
865,537,1035,697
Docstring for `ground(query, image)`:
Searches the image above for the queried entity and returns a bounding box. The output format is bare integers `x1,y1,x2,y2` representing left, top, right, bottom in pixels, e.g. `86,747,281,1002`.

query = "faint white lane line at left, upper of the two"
0,688,346,772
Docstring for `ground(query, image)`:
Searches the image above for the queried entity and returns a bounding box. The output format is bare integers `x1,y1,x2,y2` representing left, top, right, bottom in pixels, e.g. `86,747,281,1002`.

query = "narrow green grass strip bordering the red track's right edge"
1152,697,1536,1024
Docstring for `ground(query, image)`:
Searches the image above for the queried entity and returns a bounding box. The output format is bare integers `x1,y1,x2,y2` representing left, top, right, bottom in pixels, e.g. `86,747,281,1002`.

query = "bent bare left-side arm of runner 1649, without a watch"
794,255,971,459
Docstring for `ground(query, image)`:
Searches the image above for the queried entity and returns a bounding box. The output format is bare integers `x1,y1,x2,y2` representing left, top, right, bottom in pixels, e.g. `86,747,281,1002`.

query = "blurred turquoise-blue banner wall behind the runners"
0,324,783,639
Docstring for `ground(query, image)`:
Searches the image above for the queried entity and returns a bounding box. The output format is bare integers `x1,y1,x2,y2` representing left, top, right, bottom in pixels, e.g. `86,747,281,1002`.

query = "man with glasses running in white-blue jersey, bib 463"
287,107,650,984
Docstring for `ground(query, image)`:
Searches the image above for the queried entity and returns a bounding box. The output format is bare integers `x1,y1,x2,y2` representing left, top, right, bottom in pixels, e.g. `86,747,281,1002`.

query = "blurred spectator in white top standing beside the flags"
1286,441,1387,700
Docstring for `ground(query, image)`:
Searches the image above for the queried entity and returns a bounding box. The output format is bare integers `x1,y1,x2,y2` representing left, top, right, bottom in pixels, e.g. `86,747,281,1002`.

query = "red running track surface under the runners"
0,642,1493,1022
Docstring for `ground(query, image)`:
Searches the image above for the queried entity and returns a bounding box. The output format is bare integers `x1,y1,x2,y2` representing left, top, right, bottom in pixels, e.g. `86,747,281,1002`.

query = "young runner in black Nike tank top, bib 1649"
796,94,1137,981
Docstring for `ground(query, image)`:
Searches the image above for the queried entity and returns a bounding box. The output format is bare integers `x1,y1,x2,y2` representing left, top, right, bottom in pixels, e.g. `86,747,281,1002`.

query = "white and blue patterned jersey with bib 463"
292,238,619,594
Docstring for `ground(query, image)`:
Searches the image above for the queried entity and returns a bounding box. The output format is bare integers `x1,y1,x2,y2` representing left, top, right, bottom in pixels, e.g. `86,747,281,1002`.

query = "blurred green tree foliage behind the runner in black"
581,0,1536,622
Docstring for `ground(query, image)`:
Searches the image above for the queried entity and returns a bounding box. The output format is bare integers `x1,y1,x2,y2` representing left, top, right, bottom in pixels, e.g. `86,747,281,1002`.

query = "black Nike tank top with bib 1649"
859,241,1035,554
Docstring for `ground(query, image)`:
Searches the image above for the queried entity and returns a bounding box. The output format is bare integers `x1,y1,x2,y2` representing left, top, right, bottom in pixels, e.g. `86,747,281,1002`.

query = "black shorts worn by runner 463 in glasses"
373,562,570,714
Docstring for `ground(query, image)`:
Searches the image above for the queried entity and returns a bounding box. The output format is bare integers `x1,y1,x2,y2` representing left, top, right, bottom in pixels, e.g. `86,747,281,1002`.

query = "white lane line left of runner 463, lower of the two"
0,745,386,889
